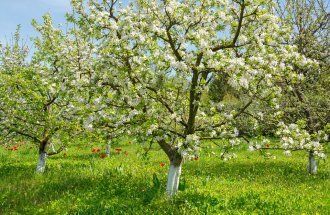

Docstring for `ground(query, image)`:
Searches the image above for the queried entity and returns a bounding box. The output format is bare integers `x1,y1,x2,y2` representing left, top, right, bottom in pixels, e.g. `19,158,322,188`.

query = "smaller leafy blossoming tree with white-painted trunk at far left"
0,15,85,172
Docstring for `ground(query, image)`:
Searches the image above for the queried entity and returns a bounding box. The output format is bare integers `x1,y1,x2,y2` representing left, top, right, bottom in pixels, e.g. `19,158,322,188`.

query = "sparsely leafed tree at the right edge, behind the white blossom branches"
278,0,330,174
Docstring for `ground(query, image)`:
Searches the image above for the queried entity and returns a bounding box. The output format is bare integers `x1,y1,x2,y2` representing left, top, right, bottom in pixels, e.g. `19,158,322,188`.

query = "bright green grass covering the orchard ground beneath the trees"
0,141,330,214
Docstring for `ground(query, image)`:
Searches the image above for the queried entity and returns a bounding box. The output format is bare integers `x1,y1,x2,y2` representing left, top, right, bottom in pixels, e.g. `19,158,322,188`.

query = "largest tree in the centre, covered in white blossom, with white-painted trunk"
72,0,310,196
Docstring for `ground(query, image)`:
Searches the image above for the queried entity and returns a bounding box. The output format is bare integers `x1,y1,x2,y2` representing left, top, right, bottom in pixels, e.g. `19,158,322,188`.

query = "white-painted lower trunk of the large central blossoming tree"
166,164,181,196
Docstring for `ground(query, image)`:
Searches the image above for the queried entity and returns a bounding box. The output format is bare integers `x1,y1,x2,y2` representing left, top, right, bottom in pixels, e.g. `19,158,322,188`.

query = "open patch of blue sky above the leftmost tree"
0,0,70,43
